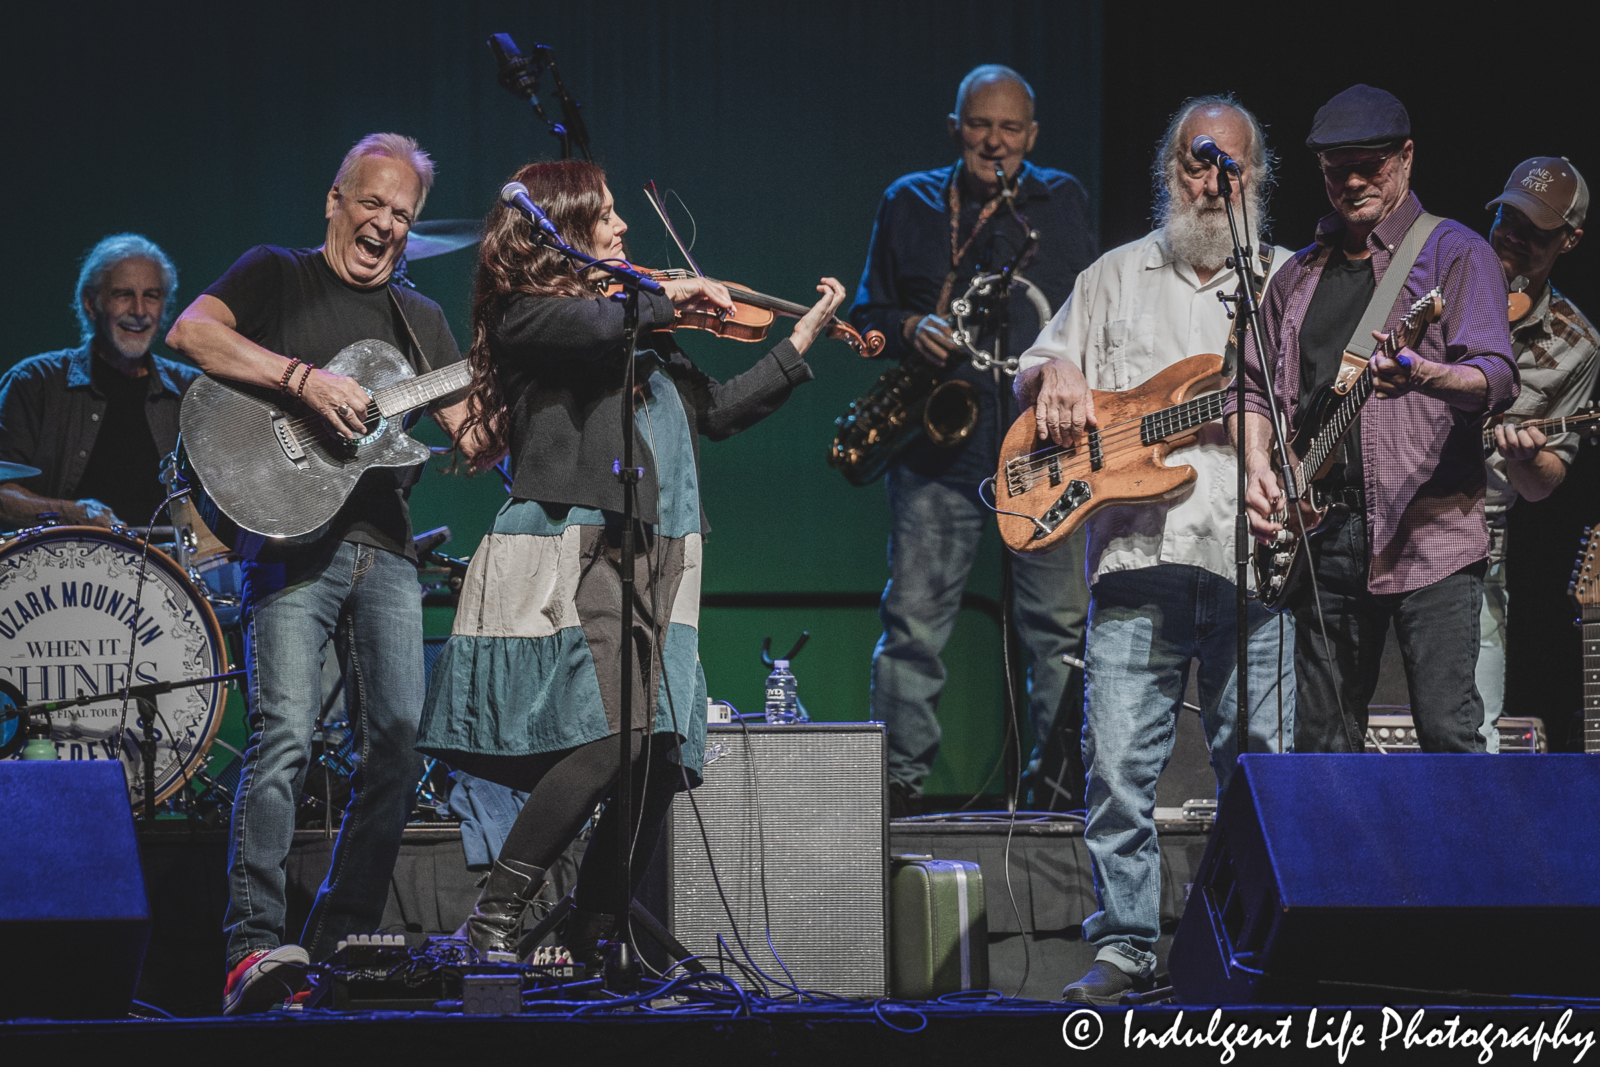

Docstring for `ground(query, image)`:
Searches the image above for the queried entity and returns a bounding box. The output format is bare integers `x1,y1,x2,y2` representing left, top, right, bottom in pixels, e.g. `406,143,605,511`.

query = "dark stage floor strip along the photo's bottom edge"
9,1001,1600,1067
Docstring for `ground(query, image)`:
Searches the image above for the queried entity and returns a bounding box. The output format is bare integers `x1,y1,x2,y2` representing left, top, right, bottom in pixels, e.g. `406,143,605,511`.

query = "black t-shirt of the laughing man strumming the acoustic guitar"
206,245,461,558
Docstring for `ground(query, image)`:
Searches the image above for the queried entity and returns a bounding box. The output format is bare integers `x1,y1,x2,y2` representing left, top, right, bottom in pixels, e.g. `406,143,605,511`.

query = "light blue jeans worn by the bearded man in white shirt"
1083,563,1294,977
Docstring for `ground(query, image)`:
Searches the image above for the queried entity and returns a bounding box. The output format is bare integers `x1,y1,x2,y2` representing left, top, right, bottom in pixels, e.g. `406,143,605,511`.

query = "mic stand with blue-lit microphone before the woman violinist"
533,224,662,987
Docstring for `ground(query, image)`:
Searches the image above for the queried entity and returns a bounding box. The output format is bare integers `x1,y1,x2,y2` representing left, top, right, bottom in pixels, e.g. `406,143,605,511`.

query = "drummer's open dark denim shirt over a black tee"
0,344,200,501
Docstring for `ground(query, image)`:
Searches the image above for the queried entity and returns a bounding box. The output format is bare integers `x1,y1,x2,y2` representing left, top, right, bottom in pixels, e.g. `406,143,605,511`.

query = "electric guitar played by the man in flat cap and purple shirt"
1254,290,1446,611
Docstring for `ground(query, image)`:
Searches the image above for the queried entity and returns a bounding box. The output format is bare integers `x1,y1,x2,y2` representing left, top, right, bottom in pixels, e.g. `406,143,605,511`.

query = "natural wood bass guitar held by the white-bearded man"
995,355,1227,553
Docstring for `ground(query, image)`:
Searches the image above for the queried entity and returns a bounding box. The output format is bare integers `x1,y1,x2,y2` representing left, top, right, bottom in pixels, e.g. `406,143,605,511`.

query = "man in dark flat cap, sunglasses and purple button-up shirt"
1245,85,1518,752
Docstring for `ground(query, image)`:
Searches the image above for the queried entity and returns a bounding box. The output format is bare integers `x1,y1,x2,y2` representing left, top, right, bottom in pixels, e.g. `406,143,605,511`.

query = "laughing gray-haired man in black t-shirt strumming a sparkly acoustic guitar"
166,133,466,1014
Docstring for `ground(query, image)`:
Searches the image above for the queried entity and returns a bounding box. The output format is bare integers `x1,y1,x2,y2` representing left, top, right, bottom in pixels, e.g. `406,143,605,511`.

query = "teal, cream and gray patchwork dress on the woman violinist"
418,371,706,787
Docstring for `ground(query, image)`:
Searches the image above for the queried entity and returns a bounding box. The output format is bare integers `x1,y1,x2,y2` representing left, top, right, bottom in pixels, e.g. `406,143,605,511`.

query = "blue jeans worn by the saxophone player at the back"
872,467,1088,793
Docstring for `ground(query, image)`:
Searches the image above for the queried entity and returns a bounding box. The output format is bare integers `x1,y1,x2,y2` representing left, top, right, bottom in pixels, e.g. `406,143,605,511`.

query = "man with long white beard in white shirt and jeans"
1016,96,1294,1005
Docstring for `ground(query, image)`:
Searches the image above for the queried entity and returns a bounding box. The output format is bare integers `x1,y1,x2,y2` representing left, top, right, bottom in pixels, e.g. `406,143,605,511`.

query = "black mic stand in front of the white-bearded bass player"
1216,166,1299,760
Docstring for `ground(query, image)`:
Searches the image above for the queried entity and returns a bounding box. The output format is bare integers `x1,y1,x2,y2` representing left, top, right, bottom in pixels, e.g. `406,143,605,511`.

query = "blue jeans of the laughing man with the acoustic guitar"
224,542,422,966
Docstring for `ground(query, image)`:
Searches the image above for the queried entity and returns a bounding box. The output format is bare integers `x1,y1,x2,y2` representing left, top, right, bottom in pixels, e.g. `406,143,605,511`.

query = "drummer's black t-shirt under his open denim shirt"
77,354,166,526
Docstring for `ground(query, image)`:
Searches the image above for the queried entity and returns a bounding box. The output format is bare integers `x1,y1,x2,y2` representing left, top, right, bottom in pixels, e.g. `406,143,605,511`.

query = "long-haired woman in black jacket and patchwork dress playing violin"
418,160,845,963
